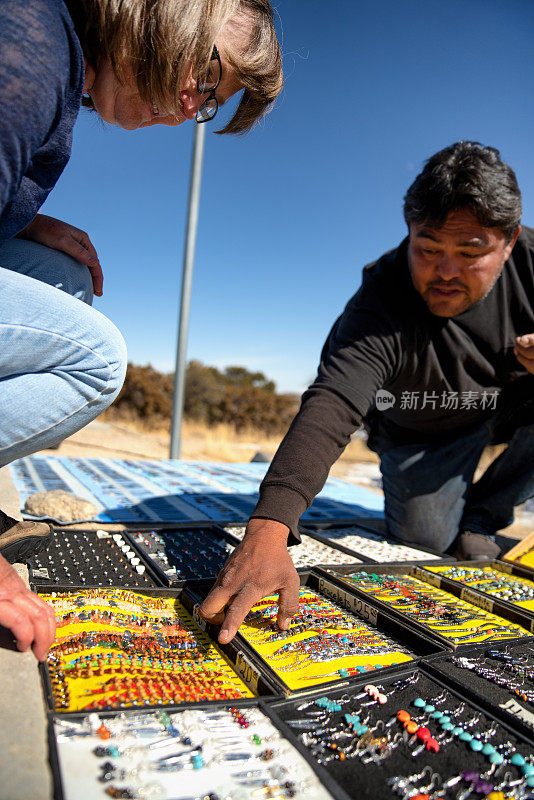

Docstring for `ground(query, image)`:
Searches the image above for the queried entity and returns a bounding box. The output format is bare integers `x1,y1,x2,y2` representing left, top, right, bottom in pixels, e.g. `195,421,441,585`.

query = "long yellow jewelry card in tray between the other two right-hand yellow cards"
329,567,529,645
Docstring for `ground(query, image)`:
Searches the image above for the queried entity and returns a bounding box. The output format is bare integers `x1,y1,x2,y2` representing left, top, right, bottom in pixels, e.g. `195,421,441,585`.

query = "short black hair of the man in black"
404,142,521,240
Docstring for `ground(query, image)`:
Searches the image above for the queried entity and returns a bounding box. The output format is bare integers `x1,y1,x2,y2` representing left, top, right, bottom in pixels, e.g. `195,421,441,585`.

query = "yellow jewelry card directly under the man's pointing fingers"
239,587,414,690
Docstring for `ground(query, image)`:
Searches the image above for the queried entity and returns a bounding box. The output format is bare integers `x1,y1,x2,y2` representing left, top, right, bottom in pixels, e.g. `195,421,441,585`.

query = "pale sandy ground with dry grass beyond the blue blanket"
35,420,534,539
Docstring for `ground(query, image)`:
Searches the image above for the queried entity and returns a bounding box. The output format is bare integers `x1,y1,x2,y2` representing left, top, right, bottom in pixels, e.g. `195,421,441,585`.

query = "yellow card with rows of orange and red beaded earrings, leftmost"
41,589,253,711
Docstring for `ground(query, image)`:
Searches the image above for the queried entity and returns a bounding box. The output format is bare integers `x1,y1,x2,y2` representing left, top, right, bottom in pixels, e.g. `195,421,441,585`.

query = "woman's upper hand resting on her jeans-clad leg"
18,214,104,297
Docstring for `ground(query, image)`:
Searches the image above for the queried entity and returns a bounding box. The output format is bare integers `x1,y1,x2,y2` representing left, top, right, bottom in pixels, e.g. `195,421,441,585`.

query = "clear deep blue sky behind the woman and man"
43,0,534,391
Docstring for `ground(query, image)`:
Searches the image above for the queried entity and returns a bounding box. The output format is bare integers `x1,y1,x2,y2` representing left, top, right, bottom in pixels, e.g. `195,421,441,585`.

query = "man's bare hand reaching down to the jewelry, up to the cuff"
199,519,300,644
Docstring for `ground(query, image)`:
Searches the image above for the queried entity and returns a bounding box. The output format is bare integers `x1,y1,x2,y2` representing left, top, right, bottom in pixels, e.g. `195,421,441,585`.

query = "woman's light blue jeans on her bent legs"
0,239,126,466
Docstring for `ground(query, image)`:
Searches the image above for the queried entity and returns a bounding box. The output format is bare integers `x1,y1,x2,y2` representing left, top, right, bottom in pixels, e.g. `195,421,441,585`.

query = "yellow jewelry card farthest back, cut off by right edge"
425,565,534,611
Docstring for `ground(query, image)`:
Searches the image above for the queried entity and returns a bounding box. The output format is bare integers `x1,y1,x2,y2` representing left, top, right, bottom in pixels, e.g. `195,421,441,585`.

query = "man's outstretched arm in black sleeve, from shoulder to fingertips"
200,281,401,643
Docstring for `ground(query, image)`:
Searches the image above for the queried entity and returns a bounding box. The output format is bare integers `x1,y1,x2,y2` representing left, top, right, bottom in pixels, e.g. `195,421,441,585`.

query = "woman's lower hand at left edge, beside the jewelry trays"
0,556,56,661
